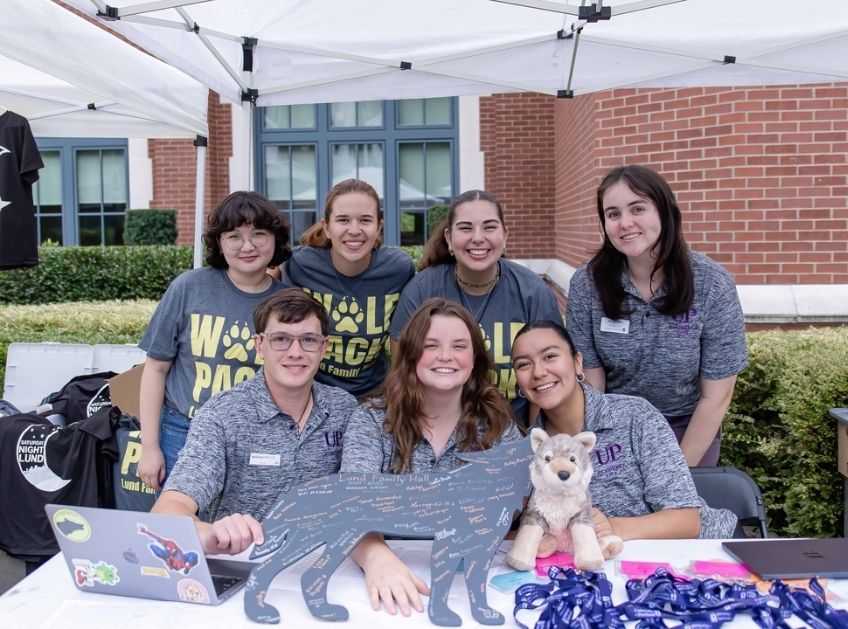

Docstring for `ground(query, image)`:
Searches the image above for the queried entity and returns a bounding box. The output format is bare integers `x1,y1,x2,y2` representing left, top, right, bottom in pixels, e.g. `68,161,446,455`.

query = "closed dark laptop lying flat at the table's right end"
721,538,848,580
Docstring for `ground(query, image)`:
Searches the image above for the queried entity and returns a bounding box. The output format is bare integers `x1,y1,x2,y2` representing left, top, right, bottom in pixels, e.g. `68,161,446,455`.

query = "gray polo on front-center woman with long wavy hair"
341,404,521,474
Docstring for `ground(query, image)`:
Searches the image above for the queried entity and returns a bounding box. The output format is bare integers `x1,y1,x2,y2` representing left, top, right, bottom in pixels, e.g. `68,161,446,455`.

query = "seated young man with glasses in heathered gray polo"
152,288,356,554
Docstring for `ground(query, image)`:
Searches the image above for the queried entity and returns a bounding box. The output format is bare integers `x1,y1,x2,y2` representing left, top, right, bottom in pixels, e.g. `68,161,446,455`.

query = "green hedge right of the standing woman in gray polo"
721,327,848,537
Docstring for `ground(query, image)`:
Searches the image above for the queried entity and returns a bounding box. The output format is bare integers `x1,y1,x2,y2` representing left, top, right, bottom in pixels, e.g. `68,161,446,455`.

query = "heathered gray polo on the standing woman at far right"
566,251,748,417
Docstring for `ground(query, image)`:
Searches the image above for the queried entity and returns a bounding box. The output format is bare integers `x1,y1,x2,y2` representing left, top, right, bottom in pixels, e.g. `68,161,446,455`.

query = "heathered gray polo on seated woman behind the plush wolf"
540,385,736,539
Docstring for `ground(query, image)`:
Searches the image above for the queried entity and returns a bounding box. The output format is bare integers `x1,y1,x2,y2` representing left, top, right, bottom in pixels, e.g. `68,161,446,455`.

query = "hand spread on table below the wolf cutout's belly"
350,533,430,616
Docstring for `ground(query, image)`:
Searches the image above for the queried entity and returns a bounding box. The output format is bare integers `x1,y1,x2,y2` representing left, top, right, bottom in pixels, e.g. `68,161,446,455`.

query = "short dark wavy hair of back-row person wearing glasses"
203,191,291,269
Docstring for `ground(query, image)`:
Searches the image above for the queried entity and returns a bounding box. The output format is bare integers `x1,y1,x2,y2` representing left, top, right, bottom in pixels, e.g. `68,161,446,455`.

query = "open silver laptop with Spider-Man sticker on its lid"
45,504,257,605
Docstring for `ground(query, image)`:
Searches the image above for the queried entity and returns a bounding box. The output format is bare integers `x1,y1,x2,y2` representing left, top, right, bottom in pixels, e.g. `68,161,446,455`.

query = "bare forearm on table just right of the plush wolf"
592,507,701,540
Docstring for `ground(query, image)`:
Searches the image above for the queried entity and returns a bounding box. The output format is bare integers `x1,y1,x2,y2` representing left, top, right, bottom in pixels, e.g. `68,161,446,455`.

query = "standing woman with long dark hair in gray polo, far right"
566,165,748,466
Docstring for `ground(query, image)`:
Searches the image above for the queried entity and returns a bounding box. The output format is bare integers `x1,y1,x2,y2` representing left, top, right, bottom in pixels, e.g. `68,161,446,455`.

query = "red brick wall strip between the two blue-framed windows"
148,91,233,245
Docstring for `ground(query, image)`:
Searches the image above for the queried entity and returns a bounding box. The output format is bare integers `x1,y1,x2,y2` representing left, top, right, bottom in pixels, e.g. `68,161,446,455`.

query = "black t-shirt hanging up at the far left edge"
0,111,44,269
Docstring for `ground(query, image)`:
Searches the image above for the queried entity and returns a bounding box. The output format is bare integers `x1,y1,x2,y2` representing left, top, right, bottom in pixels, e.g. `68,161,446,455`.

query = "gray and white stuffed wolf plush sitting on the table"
507,428,623,570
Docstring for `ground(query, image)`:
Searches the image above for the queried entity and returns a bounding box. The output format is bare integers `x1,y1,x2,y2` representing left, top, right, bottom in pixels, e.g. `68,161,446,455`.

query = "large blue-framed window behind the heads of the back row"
255,98,459,245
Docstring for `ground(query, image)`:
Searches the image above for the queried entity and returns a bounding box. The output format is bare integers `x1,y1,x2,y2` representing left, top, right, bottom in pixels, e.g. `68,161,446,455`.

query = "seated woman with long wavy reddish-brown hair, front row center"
341,298,521,615
